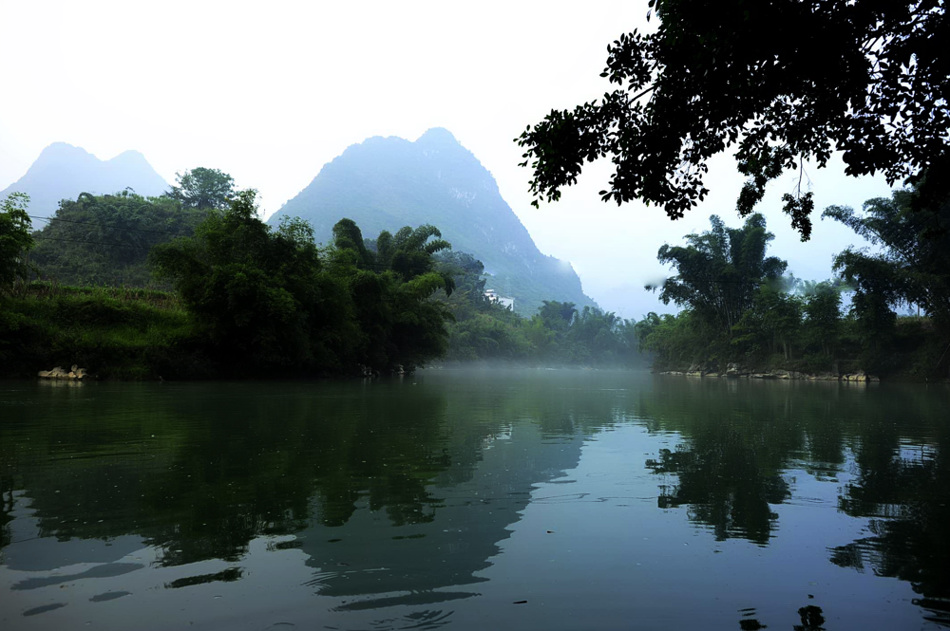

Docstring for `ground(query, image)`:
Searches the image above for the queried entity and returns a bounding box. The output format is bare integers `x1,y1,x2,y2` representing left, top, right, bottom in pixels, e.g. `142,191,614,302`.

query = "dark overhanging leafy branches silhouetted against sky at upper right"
516,0,950,240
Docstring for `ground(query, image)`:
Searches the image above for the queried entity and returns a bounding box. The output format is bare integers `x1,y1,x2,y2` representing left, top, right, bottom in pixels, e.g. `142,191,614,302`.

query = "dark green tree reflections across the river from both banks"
7,373,950,624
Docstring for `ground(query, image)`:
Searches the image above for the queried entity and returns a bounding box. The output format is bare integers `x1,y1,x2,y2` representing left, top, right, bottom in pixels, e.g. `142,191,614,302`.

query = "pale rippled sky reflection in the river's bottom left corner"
0,538,320,629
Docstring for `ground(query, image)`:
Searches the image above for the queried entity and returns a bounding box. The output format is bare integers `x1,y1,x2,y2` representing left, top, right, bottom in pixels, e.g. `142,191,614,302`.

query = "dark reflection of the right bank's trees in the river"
638,380,950,624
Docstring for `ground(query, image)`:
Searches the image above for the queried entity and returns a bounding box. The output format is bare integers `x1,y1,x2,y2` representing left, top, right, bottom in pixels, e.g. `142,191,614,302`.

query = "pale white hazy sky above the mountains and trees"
0,0,889,318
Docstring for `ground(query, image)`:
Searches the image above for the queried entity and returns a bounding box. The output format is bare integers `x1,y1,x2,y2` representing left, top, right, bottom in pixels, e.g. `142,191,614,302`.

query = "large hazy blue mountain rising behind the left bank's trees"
270,128,594,315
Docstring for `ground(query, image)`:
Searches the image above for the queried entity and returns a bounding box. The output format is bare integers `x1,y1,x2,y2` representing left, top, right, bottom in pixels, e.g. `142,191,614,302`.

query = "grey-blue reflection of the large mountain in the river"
298,425,581,609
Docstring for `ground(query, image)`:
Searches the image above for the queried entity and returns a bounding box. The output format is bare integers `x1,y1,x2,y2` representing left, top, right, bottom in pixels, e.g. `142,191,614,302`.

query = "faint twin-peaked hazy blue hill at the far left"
0,142,169,221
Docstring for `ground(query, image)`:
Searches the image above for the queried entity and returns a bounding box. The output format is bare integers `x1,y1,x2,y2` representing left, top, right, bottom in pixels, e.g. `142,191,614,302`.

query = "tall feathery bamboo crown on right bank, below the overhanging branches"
647,213,787,335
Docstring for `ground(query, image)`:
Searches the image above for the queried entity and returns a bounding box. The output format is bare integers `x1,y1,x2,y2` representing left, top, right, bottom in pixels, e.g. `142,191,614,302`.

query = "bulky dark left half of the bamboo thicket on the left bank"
149,190,358,374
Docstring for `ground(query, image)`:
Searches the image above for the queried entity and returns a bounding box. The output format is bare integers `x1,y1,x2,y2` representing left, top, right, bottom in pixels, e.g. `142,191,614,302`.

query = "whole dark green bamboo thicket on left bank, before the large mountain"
150,191,451,374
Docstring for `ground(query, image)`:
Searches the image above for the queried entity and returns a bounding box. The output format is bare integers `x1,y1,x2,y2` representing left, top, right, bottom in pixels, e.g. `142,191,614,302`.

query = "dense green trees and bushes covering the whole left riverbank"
0,175,642,378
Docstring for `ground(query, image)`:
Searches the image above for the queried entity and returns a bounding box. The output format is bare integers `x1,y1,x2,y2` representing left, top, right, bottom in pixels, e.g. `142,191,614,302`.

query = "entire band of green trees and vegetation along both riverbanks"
9,170,950,378
